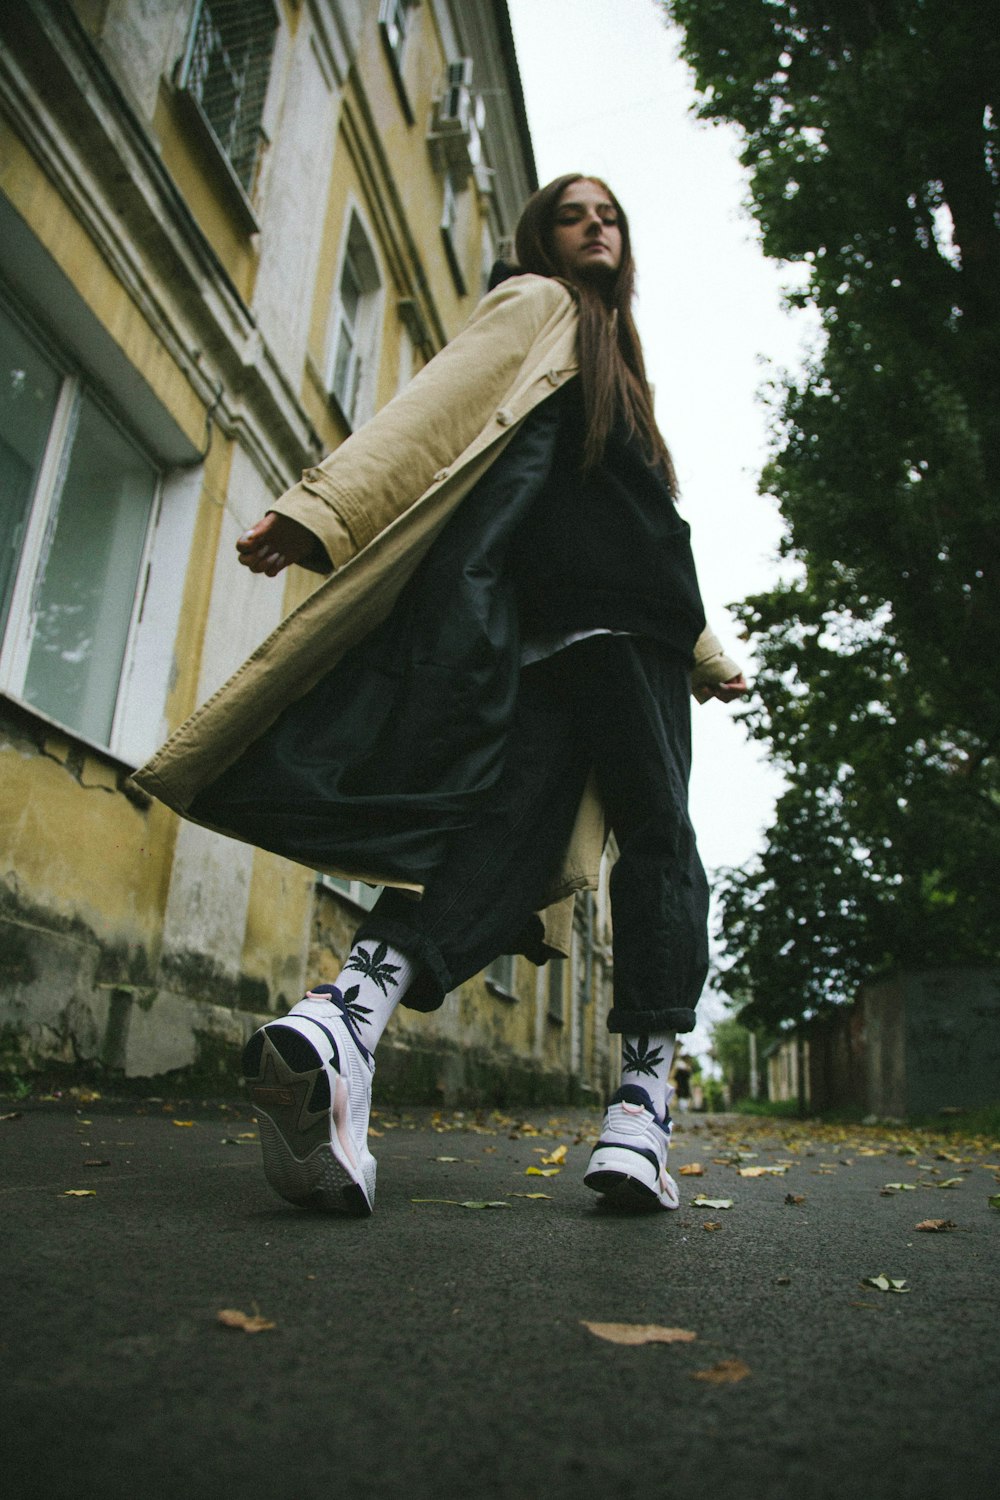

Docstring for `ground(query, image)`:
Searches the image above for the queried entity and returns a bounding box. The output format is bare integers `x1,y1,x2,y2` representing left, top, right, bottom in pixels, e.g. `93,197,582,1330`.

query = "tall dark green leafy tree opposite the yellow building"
664,0,1000,1023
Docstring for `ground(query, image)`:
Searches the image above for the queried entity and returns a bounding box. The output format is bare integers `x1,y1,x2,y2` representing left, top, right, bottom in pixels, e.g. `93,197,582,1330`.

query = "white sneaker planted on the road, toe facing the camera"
583,1083,681,1209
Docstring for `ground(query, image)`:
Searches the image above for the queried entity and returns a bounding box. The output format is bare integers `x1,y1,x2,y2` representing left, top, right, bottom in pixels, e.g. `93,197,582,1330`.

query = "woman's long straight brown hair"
514,173,678,497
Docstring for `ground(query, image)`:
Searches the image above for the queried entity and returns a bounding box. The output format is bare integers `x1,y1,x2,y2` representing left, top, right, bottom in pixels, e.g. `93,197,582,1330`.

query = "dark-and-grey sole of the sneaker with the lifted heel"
243,1023,375,1218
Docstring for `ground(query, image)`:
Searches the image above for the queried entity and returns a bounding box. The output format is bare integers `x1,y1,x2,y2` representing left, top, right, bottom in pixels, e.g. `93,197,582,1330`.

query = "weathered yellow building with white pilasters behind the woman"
0,0,609,1100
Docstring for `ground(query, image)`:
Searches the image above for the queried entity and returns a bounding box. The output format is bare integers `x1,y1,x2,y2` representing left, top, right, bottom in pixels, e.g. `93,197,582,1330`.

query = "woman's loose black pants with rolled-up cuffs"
357,636,708,1034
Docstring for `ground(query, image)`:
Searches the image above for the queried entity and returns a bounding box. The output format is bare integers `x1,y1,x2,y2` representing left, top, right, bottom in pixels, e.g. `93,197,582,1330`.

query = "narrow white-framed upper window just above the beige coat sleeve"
327,213,381,426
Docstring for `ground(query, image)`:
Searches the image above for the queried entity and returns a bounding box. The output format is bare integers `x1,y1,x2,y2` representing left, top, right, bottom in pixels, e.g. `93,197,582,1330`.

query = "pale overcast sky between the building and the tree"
508,0,808,1043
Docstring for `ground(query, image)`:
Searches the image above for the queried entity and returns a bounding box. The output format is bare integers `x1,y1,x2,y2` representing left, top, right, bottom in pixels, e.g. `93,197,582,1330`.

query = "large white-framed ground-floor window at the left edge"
0,306,160,746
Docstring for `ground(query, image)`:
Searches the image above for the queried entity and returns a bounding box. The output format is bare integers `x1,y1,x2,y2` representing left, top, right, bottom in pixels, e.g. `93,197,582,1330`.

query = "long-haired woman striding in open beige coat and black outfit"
136,174,745,1215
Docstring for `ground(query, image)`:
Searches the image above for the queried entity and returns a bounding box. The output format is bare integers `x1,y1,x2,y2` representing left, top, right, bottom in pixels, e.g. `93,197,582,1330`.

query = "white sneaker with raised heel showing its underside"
243,984,376,1218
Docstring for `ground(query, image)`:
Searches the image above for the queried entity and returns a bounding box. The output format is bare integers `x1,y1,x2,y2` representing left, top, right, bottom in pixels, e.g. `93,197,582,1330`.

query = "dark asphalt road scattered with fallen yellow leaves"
0,1098,1000,1500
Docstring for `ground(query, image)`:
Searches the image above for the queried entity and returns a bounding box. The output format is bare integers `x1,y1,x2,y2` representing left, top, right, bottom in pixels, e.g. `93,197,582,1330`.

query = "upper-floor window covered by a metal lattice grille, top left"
178,0,277,195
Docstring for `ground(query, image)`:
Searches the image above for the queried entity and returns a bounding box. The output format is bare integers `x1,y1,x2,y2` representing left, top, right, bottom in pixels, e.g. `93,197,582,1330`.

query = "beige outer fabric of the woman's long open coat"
133,276,739,953
